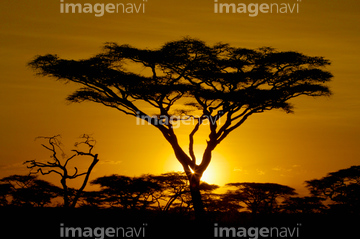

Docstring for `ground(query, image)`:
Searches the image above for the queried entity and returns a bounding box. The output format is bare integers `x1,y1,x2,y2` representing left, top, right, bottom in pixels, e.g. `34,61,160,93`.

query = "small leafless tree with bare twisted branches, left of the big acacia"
24,134,99,207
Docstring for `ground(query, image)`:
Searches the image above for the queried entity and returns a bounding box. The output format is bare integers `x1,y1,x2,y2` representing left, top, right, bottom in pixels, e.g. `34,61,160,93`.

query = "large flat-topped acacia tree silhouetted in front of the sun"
29,38,332,217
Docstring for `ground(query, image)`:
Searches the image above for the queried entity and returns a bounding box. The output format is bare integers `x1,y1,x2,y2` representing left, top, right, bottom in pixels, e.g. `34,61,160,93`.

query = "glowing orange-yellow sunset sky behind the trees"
0,0,360,192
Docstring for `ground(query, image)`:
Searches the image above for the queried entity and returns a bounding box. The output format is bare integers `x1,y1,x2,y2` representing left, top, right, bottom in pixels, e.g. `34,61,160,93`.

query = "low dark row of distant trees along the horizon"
0,166,360,214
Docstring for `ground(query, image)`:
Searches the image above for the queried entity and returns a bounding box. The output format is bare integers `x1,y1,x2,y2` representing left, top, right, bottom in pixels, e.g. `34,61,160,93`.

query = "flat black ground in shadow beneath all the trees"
0,208,358,239
